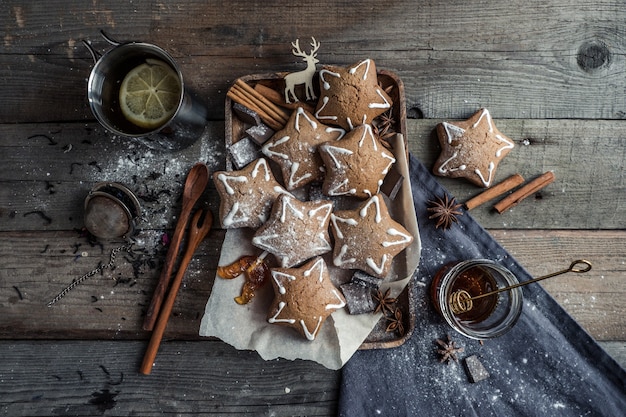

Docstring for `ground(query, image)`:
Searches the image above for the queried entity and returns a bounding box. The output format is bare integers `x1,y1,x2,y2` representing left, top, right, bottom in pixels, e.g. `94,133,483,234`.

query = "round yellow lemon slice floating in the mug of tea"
120,59,181,129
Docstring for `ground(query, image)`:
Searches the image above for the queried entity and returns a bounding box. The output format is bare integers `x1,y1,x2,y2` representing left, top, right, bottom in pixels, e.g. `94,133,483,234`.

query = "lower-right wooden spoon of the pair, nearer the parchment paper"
139,210,213,375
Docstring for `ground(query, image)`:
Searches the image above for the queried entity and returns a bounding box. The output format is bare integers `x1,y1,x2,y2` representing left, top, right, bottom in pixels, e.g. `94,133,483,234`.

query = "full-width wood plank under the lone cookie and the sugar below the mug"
0,119,626,230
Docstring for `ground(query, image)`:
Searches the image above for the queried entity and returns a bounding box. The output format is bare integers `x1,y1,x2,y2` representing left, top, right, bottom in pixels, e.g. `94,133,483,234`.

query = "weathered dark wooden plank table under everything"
0,0,626,416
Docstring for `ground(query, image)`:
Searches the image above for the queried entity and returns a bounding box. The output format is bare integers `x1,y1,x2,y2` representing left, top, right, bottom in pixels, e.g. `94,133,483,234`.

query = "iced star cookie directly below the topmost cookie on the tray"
319,125,396,199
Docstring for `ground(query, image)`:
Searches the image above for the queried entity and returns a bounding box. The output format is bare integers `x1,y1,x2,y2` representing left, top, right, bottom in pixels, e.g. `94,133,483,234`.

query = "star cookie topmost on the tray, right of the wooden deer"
315,59,393,130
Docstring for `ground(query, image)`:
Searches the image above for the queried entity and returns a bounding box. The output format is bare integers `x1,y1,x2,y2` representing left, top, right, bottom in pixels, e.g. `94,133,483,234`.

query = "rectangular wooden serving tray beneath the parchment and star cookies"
225,70,418,350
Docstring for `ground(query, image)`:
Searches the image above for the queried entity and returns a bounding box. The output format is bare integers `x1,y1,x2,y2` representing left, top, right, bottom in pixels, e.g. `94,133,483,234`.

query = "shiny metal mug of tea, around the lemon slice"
83,32,208,151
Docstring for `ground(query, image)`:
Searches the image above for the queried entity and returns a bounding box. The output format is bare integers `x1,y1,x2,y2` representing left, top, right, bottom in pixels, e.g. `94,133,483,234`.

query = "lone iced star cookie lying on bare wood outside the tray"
433,109,515,188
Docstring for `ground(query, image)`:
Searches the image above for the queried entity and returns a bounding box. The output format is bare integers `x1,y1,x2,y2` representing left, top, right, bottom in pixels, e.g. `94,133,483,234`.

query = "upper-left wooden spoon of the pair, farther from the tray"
143,162,209,330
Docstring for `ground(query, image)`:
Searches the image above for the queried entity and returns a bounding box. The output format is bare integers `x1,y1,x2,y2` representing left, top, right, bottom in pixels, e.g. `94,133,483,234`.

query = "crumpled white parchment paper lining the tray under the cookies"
199,135,421,369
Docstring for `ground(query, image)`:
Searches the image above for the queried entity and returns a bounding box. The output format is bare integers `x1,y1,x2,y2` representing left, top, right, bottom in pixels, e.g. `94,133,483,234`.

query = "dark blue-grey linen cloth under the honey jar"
338,156,626,417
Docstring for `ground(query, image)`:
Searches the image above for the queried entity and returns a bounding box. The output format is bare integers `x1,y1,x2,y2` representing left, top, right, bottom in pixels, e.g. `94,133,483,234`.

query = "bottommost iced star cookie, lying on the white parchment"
267,257,346,341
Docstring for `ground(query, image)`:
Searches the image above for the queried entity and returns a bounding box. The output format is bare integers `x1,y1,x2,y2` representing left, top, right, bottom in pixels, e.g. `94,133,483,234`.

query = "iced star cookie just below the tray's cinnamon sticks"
261,107,345,190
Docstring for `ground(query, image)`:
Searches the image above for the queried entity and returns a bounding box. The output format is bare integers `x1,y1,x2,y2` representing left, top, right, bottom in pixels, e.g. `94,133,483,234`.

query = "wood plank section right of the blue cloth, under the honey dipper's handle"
491,230,626,340
